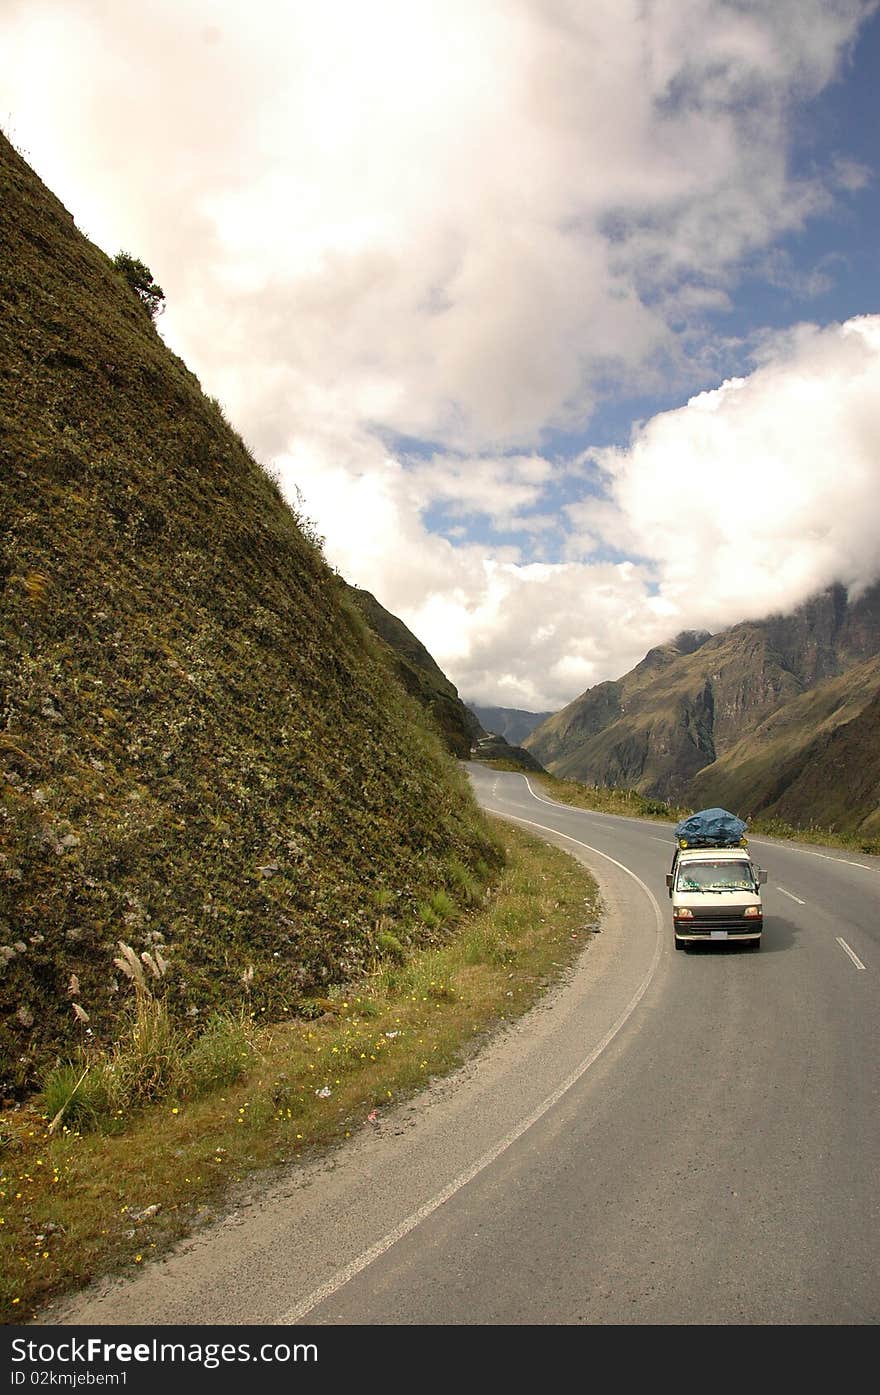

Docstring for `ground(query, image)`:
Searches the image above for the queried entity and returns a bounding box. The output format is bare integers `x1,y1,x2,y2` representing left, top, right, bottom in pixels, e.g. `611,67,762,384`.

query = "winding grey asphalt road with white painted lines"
39,766,880,1325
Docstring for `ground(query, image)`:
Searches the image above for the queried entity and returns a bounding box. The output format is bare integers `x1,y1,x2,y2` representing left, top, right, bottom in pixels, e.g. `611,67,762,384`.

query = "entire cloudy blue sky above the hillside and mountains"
0,0,880,710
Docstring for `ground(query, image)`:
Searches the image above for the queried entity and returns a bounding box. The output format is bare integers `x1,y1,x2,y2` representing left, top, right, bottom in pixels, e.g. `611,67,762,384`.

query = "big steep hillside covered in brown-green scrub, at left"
0,138,498,1096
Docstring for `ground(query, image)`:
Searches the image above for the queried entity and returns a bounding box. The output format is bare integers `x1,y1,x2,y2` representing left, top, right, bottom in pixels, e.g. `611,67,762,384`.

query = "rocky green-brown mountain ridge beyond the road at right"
523,583,880,831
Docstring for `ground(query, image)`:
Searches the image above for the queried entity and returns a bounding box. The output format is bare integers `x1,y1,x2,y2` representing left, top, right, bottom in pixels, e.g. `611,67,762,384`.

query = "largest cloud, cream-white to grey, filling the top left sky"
0,0,860,451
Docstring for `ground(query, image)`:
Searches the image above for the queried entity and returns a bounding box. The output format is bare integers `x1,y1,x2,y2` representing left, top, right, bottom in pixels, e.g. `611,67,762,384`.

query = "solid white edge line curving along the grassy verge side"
278,809,662,1327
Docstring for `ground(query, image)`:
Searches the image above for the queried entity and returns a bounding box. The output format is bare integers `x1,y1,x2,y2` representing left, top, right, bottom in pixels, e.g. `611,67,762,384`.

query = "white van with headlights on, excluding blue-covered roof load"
667,847,767,950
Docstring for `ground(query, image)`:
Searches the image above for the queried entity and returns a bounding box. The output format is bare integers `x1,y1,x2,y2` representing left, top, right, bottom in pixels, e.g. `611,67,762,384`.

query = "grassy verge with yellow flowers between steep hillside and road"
0,822,598,1322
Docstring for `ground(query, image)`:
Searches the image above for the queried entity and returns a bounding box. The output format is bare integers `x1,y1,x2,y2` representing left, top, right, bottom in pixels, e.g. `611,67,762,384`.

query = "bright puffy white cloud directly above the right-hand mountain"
572,315,880,628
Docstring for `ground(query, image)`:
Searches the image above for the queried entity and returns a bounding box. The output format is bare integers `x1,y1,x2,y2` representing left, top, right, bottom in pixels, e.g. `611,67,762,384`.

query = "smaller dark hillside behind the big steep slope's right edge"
349,586,483,760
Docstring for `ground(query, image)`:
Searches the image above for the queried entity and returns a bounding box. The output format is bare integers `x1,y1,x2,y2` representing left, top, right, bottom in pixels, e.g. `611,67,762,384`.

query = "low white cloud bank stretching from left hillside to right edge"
289,317,880,710
